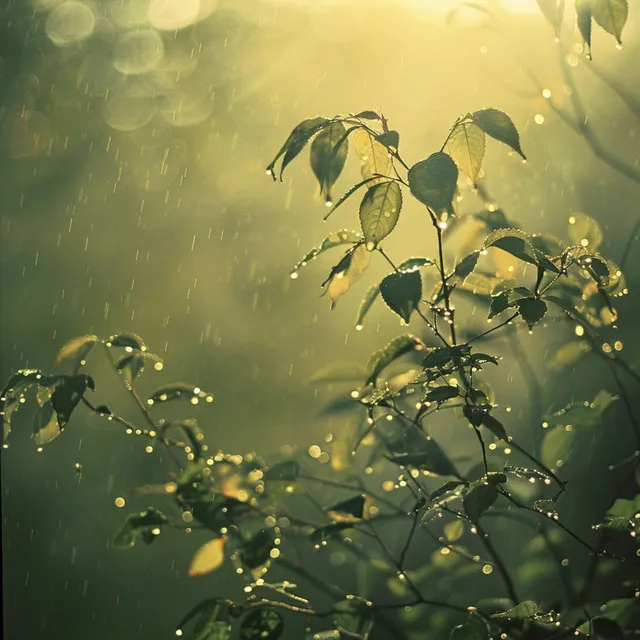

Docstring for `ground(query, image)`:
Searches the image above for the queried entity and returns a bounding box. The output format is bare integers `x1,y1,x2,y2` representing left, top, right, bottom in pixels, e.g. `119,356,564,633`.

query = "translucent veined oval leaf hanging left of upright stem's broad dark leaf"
360,180,402,250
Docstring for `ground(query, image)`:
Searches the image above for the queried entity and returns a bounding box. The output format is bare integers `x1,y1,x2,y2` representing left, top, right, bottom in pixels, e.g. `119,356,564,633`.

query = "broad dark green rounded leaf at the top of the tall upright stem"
408,151,458,213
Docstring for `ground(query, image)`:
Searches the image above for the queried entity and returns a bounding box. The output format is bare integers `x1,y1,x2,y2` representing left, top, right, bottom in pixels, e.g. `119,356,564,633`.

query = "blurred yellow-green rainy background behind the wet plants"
0,0,640,640
